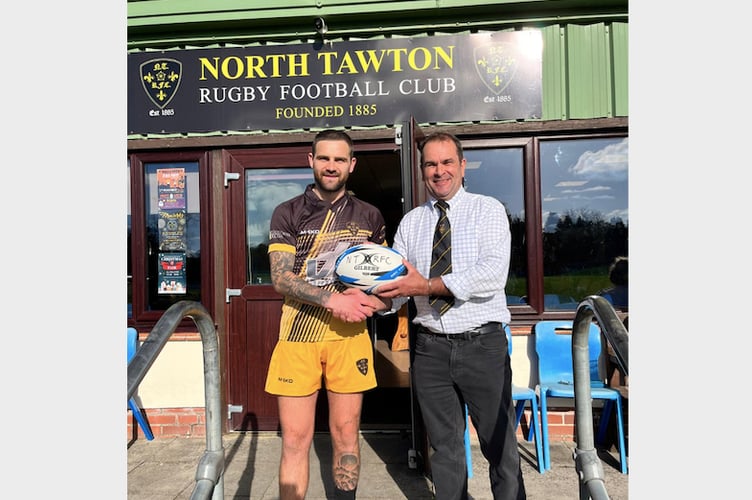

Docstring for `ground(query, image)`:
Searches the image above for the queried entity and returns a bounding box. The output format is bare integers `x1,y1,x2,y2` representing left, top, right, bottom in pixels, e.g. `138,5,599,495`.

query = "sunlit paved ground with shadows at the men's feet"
128,432,629,500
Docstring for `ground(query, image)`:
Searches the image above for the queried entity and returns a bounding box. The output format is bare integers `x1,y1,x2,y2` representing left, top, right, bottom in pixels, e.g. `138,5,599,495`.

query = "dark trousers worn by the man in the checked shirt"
412,328,526,500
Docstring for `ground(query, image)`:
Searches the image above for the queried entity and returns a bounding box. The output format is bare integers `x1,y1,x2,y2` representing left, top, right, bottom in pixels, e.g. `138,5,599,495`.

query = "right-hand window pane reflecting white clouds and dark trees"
540,137,629,309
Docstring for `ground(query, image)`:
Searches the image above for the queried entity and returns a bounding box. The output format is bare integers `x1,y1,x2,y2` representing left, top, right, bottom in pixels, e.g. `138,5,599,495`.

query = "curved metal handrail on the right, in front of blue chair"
572,295,629,500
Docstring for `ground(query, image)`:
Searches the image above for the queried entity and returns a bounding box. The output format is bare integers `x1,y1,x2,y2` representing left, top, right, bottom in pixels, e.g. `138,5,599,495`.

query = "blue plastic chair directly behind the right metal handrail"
535,321,627,474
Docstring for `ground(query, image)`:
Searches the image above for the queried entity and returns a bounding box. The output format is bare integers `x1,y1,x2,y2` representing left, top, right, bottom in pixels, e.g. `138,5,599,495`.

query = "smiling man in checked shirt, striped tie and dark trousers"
377,132,526,500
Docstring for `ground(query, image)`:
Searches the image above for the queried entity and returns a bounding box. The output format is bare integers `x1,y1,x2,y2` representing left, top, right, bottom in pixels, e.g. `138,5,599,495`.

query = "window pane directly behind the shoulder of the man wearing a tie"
465,147,527,305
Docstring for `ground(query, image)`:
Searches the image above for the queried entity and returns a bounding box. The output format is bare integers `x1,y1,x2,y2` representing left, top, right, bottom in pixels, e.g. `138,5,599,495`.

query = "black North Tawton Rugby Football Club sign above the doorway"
128,30,542,134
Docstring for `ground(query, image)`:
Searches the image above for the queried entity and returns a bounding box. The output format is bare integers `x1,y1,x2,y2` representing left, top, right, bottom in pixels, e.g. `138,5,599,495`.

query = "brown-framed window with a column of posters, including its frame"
128,152,211,321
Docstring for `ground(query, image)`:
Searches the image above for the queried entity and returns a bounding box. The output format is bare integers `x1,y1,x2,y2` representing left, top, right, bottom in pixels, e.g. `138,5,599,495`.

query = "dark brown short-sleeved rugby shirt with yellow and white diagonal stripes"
269,184,386,342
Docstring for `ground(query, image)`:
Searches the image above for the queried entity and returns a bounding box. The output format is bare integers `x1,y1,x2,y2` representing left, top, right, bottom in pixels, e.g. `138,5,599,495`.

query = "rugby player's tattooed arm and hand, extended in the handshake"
269,252,383,323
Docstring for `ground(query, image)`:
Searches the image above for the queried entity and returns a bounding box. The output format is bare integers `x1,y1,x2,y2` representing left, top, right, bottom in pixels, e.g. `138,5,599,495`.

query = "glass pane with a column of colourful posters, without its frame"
144,162,201,310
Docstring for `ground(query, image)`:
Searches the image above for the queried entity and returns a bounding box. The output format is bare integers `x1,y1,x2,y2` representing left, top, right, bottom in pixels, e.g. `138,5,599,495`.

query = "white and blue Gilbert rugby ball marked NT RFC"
334,244,407,293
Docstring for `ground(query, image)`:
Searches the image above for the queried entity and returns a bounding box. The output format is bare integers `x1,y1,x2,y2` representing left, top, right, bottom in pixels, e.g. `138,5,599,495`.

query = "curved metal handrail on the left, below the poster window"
127,300,225,500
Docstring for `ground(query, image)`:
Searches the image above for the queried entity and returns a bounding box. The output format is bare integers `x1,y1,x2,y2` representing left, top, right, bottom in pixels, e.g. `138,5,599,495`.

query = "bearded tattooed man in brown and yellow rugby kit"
266,130,391,500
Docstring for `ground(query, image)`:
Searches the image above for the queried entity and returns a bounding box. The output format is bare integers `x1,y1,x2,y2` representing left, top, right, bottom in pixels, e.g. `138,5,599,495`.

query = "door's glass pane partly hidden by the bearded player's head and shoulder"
245,167,313,285
